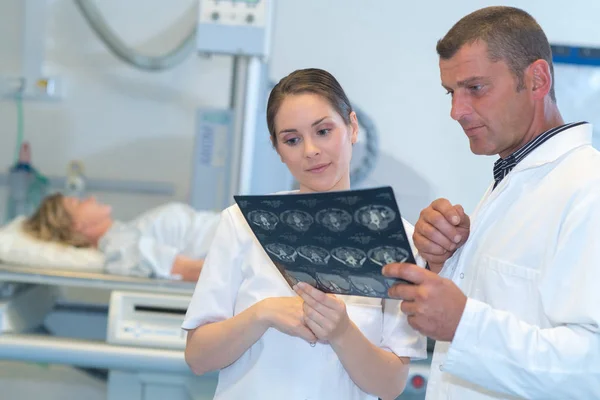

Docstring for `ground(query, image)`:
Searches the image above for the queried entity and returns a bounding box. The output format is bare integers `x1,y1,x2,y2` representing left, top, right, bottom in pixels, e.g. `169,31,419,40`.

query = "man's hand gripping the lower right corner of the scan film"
383,263,467,342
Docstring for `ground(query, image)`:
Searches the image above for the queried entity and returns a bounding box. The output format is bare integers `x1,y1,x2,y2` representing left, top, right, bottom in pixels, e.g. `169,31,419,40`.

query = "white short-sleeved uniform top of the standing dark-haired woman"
182,205,426,400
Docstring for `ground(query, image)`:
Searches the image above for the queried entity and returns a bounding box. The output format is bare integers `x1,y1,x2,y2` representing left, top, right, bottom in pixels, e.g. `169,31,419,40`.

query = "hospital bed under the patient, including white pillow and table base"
0,203,217,400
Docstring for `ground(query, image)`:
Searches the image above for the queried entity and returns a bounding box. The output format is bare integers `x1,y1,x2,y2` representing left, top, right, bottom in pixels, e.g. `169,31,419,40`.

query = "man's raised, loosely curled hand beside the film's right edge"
413,199,471,272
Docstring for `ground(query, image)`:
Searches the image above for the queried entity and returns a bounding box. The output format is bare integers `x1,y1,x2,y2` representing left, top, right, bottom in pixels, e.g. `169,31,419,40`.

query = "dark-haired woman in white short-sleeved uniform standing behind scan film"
182,69,425,400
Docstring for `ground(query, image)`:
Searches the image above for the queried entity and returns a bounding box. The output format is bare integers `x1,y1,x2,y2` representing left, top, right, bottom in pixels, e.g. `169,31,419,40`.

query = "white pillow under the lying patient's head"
0,217,104,272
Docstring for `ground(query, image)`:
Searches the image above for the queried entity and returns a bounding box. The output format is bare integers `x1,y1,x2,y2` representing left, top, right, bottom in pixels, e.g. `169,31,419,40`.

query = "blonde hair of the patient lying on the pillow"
23,193,91,247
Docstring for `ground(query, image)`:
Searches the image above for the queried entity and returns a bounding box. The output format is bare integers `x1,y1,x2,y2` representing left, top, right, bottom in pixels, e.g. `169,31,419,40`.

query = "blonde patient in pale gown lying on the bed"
23,193,219,281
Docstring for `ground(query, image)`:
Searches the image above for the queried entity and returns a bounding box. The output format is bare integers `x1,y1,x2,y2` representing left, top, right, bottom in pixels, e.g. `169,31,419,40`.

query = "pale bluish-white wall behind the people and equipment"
0,0,600,220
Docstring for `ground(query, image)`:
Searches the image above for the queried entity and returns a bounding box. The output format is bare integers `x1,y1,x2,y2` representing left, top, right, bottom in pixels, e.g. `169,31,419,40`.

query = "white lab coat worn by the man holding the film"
427,124,600,400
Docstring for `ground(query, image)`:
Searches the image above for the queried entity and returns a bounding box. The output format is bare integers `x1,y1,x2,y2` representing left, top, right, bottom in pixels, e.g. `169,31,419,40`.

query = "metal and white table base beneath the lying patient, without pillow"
0,263,217,400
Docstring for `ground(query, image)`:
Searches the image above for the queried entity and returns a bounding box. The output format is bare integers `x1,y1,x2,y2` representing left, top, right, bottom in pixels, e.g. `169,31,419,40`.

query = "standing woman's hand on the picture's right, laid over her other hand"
294,282,350,342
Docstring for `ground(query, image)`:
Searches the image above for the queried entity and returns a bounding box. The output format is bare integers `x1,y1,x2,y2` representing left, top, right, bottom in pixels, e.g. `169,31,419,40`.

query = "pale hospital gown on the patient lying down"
98,203,219,278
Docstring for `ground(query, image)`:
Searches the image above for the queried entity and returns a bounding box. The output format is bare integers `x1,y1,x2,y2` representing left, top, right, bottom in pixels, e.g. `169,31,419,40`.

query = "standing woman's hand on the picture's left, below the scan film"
257,296,317,343
